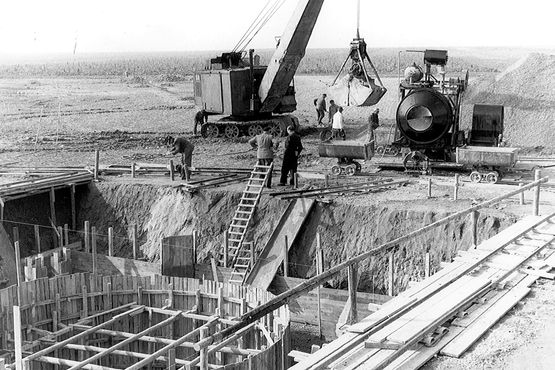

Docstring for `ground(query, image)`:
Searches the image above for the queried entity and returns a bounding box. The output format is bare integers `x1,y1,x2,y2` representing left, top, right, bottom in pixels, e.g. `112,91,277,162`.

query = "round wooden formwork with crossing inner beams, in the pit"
0,274,290,370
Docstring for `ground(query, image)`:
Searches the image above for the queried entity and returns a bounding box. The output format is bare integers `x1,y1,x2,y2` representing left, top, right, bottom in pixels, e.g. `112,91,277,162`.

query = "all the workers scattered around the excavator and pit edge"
171,99,380,184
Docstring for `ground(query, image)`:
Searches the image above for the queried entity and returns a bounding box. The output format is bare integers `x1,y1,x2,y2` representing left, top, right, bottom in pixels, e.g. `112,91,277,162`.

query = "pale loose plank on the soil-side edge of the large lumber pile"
441,287,531,357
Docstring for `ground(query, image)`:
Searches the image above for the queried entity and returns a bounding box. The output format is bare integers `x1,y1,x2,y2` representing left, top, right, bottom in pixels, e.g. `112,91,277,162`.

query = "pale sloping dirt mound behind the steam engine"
465,53,555,148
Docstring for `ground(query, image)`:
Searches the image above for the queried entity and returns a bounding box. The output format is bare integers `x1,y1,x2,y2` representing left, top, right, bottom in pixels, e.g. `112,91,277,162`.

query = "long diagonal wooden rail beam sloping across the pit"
195,177,552,351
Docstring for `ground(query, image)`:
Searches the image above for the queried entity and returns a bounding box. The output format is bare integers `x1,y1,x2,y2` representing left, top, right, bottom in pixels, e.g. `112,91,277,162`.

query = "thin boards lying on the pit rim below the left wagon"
270,179,408,200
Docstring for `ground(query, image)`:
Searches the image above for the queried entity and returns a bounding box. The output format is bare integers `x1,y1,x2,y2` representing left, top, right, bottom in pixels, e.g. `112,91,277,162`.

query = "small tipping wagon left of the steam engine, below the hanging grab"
318,140,374,176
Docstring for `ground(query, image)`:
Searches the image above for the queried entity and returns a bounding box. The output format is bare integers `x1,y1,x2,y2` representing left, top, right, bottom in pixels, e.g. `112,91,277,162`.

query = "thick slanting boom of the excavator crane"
258,0,324,112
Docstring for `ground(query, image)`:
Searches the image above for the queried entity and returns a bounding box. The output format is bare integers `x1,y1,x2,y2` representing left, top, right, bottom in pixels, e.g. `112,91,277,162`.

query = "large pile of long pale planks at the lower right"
293,214,555,370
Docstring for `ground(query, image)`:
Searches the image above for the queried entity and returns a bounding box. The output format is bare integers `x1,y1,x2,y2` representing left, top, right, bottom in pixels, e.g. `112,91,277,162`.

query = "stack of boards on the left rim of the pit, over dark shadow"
0,171,93,201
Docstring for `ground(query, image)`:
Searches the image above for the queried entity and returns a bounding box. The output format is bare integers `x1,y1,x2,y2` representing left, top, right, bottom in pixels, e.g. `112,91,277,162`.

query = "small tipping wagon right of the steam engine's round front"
456,146,518,184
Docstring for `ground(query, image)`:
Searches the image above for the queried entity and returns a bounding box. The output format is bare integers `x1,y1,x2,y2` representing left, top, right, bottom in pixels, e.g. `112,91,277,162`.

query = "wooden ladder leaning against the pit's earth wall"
227,164,273,284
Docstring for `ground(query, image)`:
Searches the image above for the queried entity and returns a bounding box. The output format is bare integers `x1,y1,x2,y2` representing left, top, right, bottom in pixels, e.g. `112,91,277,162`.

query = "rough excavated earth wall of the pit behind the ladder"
79,182,516,294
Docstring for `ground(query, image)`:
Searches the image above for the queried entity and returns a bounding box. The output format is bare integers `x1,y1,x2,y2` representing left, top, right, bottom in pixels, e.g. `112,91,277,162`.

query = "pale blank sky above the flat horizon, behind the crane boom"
0,0,555,54
